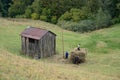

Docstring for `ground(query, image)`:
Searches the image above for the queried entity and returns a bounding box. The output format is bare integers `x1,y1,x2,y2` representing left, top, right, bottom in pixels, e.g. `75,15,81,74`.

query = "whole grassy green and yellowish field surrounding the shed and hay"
0,18,120,80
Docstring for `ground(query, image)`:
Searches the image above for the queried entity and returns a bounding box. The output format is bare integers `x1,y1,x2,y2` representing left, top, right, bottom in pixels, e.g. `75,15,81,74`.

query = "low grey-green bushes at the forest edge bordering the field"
58,20,96,32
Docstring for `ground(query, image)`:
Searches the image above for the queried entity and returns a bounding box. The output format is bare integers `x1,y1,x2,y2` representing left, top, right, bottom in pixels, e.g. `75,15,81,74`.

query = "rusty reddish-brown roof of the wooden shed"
21,27,56,40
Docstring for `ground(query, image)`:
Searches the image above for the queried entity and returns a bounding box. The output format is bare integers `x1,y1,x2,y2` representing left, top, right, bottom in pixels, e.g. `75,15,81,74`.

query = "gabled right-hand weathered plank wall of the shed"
39,32,56,57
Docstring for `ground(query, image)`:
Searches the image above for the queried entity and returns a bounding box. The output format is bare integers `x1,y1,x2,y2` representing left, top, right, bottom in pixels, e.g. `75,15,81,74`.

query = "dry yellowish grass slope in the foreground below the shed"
0,50,120,80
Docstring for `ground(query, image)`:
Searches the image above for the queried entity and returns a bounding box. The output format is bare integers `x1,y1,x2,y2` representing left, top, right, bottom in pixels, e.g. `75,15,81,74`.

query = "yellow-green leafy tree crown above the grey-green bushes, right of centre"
59,7,90,22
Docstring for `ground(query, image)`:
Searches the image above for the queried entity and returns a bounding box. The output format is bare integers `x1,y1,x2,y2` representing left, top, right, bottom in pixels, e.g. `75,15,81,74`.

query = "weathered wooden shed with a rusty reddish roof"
21,27,56,59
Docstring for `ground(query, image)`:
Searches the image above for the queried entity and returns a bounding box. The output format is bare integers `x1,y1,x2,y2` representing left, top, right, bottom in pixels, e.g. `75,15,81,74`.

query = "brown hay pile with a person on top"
70,48,87,64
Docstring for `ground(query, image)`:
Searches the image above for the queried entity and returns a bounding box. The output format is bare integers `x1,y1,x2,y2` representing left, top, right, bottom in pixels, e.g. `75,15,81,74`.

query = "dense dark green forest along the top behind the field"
0,0,120,32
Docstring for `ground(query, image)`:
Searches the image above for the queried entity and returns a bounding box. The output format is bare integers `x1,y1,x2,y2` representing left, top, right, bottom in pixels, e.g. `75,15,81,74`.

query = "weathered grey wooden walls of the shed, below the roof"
21,32,56,58
